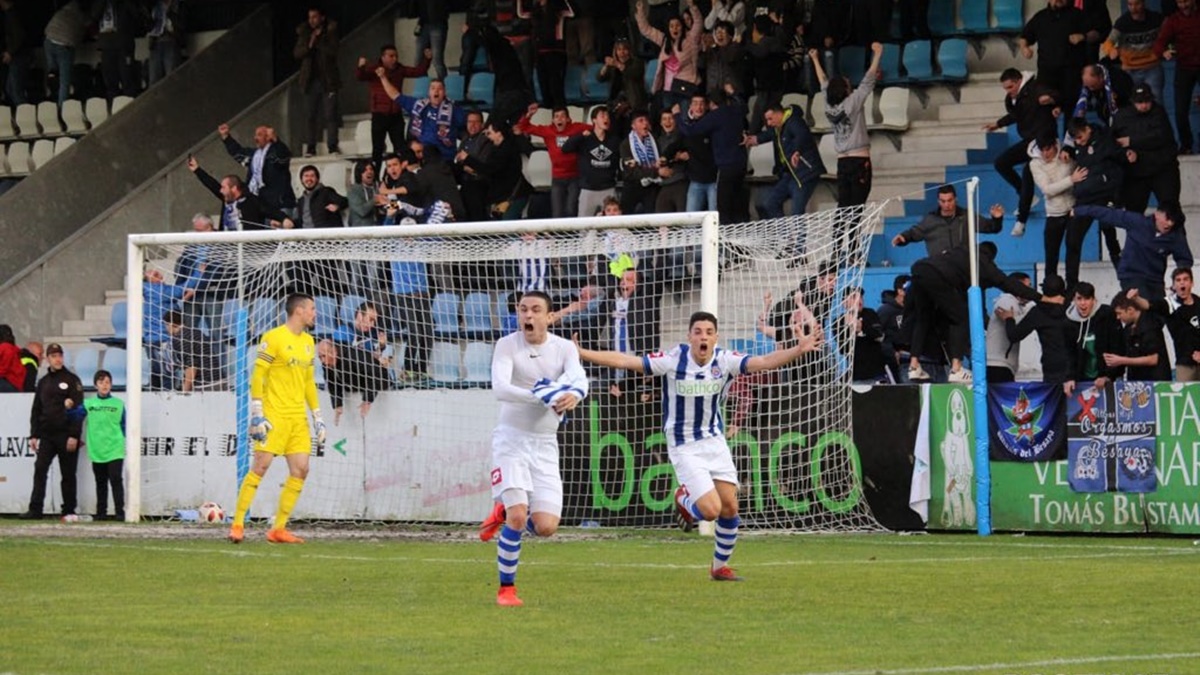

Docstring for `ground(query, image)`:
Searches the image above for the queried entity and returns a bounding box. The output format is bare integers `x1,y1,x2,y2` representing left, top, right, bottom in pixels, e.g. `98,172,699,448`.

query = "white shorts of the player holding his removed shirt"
492,426,563,516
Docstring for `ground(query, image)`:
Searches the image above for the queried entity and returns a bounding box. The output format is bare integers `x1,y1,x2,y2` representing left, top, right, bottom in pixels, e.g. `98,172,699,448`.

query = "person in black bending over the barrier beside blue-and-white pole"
904,241,1042,382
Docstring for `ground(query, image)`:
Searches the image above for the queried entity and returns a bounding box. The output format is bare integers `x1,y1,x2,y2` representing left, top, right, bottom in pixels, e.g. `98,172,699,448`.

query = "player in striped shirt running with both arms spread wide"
580,312,821,581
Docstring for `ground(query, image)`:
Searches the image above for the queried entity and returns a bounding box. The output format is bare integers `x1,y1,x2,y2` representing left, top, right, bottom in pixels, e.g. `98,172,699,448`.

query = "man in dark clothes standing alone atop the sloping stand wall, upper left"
292,7,342,157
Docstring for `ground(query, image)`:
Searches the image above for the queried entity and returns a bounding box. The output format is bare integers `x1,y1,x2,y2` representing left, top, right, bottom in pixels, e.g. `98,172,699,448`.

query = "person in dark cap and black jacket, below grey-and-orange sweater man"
1112,84,1182,214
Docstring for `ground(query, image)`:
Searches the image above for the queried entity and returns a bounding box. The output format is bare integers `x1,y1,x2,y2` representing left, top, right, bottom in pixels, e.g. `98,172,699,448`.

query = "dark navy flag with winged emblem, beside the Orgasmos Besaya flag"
988,382,1067,461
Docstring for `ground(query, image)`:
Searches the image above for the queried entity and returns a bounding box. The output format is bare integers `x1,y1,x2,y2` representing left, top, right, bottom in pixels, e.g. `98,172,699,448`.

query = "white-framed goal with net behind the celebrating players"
128,204,881,530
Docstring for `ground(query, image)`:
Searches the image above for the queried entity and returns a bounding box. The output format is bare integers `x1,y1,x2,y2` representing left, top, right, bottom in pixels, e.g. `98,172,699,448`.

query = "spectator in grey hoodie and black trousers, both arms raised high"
809,42,883,251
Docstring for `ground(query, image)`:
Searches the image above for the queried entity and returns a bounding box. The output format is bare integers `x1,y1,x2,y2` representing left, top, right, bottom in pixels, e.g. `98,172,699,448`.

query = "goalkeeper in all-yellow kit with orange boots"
229,293,325,544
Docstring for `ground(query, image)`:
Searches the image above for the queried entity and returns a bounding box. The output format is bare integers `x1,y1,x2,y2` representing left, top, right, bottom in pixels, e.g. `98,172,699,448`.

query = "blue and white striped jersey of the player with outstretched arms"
642,345,750,448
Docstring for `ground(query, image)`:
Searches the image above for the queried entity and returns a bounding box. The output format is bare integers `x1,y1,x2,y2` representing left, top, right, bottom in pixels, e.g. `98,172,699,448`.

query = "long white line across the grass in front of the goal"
28,539,1198,569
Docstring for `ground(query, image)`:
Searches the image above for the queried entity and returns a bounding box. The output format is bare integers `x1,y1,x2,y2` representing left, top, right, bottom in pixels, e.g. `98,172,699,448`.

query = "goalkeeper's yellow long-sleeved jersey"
250,324,318,418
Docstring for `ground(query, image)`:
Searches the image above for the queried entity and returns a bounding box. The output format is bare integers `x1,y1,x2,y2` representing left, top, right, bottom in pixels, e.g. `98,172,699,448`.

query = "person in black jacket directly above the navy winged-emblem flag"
996,270,1074,384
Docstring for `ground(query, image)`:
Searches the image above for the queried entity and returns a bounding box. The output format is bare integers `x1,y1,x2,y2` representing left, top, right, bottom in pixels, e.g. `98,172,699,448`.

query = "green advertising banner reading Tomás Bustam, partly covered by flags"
928,382,1200,534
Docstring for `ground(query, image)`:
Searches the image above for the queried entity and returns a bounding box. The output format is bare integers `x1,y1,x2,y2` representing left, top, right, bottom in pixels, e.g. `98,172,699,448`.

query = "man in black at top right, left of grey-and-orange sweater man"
1016,0,1094,95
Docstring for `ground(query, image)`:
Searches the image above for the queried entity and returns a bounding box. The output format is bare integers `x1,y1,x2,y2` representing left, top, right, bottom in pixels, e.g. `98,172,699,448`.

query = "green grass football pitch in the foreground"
0,521,1200,675
